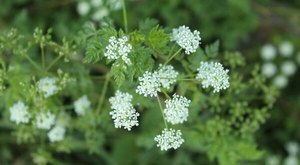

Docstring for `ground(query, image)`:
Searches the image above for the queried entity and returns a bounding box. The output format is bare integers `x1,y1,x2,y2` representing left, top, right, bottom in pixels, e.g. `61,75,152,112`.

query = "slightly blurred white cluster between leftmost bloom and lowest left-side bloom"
36,111,55,130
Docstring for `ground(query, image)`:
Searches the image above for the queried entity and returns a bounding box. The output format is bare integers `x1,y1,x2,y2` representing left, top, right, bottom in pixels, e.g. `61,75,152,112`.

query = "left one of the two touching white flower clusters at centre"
136,71,161,97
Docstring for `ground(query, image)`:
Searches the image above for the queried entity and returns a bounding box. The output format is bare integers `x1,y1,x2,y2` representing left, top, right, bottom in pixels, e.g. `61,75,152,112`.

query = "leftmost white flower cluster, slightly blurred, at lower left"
9,101,30,124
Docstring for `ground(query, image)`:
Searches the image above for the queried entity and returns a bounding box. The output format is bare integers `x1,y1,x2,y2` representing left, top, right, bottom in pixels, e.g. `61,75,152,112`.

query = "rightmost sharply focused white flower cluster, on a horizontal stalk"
196,62,229,93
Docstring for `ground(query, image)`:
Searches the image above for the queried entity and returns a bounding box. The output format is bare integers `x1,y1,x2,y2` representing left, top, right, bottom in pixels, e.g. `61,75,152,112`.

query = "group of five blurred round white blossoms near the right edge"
260,41,297,88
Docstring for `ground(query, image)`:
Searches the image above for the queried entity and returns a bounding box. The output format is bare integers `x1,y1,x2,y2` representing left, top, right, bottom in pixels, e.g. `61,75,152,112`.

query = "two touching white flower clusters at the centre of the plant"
136,65,179,97
